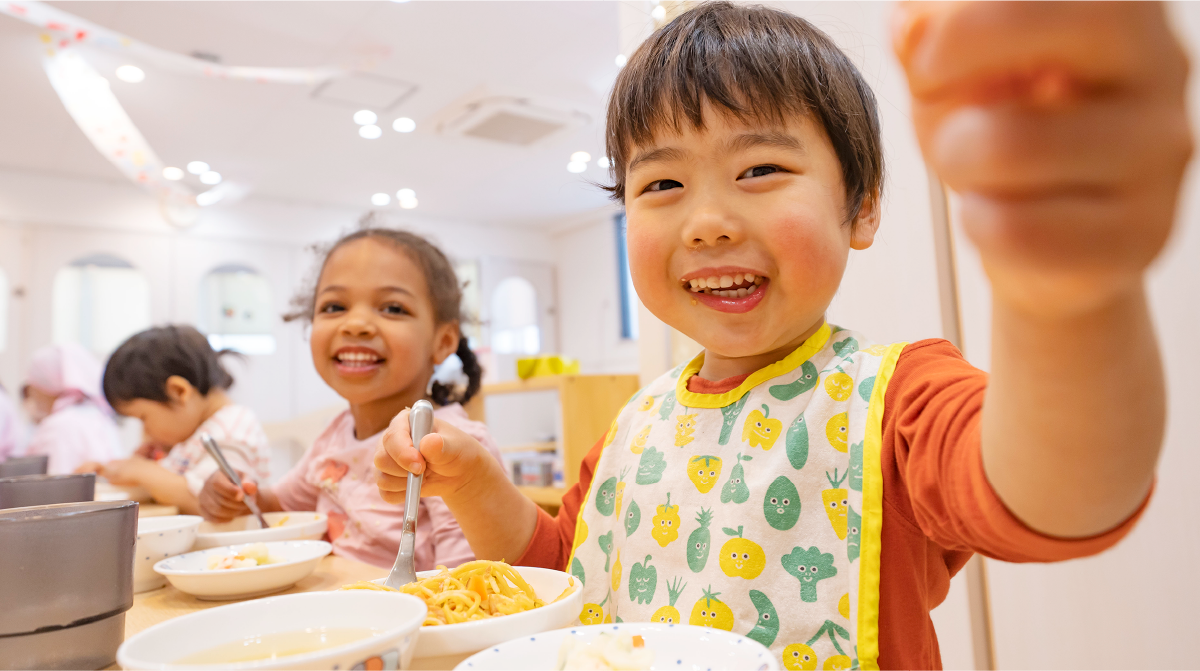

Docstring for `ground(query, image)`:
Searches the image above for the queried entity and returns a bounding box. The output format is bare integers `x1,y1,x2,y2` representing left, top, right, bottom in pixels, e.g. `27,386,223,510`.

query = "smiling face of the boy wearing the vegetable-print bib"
625,108,878,365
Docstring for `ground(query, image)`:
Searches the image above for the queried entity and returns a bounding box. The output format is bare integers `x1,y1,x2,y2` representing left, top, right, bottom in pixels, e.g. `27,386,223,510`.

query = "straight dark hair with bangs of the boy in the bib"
605,0,883,222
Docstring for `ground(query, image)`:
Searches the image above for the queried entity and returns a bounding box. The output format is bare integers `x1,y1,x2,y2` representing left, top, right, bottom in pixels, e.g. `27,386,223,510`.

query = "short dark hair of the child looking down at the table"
104,325,233,407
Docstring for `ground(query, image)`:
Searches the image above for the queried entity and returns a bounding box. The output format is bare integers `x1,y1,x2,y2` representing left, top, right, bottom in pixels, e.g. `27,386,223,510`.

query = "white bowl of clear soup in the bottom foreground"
116,591,426,671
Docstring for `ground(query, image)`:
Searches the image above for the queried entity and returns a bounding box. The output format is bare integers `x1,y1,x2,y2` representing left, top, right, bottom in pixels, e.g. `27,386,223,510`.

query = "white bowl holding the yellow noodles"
374,567,583,666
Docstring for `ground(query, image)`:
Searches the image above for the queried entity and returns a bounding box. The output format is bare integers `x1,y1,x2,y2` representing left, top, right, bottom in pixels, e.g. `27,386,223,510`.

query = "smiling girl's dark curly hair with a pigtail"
283,225,484,406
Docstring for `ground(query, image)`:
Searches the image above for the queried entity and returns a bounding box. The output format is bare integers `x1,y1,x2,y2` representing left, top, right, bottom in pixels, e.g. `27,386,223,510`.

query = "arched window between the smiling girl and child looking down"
197,264,275,354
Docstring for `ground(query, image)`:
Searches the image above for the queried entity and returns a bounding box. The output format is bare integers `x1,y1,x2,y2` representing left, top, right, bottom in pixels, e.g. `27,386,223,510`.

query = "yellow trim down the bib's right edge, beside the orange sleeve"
858,342,908,671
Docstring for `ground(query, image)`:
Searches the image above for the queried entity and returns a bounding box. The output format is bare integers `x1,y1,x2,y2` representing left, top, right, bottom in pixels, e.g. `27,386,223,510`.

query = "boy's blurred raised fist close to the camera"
894,0,1192,317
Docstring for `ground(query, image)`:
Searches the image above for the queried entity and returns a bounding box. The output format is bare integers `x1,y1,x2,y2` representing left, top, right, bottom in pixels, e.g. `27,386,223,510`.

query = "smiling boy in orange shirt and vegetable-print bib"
376,0,1190,671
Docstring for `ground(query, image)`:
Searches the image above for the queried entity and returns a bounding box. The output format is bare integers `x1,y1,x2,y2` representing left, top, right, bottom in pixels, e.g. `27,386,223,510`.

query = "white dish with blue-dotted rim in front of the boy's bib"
453,622,779,671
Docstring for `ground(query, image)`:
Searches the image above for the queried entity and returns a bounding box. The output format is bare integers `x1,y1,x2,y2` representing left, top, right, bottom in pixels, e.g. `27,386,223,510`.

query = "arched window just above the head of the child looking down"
50,254,150,359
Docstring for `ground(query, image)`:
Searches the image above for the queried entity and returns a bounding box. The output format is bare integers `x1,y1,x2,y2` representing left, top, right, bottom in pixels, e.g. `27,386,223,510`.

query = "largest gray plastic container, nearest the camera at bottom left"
0,501,138,671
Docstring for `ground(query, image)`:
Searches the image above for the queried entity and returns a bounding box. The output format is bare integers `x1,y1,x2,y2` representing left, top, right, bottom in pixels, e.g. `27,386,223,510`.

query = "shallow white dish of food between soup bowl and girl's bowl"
154,540,334,601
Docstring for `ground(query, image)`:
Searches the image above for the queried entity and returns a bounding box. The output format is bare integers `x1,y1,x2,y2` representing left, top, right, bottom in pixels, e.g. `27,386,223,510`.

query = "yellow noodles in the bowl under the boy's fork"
342,559,578,627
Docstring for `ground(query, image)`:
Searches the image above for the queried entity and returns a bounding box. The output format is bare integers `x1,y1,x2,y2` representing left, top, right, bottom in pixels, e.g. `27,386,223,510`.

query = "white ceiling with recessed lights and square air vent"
0,0,618,224
